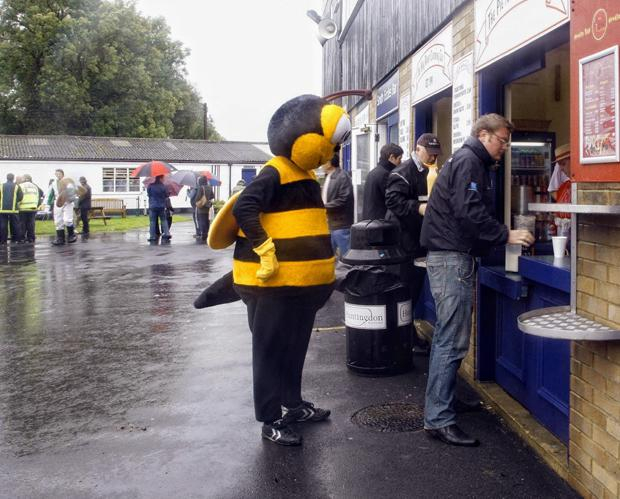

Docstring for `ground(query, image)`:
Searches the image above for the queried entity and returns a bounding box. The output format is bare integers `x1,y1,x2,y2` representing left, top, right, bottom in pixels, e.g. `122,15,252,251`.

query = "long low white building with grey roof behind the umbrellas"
0,135,271,210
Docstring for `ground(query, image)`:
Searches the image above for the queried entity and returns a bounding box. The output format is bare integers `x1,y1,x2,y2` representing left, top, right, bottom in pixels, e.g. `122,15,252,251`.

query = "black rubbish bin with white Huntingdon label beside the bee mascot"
340,220,412,376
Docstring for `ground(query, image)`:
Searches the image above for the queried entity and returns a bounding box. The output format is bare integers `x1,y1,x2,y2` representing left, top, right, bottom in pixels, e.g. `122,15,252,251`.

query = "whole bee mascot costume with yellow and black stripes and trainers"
201,95,351,445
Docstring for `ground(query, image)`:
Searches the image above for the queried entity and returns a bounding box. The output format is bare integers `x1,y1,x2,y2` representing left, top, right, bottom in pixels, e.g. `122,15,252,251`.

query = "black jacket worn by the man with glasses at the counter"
420,137,508,256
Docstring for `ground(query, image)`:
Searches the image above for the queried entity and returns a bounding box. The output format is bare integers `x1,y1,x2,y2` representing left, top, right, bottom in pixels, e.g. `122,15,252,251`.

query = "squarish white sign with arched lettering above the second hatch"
411,23,452,105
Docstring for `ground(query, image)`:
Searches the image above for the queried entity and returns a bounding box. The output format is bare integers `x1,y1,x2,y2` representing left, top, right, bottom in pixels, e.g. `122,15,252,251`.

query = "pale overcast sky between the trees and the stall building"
136,0,323,145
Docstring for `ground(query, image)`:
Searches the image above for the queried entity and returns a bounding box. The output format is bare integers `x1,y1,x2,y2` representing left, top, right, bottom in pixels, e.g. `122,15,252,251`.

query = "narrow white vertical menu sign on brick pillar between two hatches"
452,52,474,152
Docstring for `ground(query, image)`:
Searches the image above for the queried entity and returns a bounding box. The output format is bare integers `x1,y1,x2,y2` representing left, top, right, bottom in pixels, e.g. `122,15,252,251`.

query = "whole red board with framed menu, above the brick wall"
570,0,620,182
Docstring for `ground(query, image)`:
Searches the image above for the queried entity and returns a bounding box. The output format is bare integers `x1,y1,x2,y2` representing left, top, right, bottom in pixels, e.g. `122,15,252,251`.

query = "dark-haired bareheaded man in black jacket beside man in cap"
362,143,403,220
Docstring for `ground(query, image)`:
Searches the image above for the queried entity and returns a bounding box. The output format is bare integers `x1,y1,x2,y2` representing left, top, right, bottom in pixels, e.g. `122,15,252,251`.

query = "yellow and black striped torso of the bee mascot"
233,156,335,289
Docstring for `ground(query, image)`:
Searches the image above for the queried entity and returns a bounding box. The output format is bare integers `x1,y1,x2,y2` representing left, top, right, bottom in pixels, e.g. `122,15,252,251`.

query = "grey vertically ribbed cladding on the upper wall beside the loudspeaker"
323,0,467,107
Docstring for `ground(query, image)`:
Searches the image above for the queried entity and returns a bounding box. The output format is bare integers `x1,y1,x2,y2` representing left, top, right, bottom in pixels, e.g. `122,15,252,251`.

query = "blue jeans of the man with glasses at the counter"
424,251,476,430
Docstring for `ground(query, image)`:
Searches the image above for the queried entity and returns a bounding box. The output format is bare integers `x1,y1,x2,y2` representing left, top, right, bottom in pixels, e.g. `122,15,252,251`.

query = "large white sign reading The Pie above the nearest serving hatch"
474,0,571,71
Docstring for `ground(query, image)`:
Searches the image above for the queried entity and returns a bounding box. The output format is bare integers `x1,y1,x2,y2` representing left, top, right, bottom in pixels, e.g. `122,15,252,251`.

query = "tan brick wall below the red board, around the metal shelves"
569,184,620,498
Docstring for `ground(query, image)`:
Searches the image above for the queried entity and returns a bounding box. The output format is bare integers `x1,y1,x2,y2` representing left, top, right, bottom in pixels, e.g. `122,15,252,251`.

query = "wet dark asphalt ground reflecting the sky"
0,223,578,499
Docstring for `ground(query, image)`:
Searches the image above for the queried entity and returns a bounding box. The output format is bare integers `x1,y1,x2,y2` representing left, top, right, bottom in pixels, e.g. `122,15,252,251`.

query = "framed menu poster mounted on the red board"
579,45,620,163
